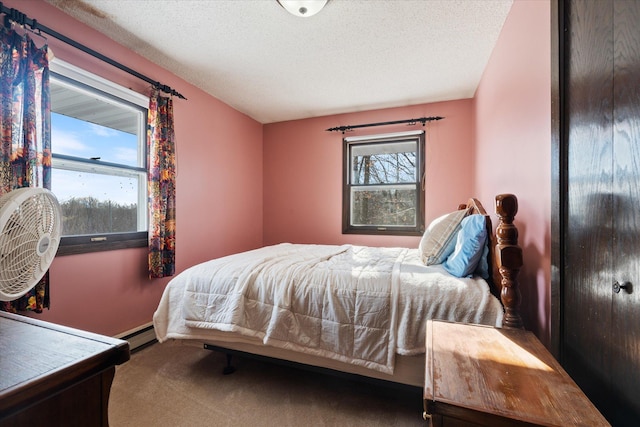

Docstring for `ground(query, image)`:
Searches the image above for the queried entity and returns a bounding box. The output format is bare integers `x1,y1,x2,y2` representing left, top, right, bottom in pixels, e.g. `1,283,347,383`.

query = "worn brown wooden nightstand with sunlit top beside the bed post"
424,321,609,427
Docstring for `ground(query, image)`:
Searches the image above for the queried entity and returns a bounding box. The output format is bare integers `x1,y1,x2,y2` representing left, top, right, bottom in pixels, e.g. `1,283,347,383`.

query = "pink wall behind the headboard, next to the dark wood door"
475,0,551,345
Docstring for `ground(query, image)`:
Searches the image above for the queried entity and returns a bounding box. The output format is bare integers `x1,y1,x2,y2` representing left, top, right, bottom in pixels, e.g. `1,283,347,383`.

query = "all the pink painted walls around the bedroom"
4,0,551,341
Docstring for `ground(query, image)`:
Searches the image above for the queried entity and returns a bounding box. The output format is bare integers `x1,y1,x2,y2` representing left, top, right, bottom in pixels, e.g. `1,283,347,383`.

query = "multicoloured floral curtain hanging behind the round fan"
0,27,51,313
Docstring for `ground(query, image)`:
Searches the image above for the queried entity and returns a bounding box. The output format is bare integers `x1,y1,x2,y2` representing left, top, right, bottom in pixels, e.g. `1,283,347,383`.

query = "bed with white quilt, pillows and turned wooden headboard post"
153,194,522,387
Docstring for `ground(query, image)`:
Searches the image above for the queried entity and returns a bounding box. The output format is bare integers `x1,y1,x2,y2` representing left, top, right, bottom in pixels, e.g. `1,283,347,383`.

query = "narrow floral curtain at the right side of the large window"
147,88,176,279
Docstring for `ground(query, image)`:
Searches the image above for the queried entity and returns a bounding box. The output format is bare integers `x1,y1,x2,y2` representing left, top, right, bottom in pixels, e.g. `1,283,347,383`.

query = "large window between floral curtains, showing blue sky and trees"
50,60,149,255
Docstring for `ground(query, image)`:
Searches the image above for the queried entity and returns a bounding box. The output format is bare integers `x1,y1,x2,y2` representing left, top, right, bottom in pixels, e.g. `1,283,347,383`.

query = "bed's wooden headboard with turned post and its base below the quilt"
179,194,522,387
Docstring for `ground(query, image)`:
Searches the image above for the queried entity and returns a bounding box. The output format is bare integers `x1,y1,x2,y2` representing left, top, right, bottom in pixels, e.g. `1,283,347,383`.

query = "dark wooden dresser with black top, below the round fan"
0,312,129,427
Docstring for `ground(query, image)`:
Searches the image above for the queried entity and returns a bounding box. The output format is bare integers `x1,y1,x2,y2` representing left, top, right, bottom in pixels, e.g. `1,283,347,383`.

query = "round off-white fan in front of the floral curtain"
0,187,62,301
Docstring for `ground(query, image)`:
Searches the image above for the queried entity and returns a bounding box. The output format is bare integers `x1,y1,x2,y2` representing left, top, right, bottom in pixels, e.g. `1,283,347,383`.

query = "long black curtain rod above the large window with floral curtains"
0,2,187,99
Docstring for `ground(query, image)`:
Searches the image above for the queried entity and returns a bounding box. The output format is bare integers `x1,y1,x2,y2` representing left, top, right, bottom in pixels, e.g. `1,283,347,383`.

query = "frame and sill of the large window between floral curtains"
50,58,149,256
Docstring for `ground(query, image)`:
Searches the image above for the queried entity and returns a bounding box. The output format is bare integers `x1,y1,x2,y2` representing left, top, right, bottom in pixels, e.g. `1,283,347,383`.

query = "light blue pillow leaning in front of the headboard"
444,215,487,277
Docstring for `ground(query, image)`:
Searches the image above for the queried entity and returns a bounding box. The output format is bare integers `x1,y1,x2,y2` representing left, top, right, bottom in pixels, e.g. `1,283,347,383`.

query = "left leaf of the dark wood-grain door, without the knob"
562,0,613,418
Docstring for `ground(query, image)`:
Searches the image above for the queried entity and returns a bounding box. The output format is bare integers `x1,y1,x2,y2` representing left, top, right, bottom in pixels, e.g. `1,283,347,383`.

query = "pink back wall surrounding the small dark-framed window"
264,100,475,247
